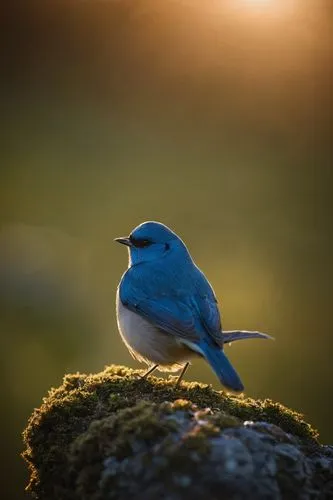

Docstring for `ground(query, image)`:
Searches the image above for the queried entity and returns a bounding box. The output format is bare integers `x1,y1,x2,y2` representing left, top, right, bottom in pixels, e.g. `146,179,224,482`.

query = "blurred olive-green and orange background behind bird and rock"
0,0,333,499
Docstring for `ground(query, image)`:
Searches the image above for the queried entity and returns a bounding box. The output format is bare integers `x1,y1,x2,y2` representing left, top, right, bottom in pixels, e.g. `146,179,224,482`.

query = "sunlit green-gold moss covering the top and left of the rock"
24,366,318,500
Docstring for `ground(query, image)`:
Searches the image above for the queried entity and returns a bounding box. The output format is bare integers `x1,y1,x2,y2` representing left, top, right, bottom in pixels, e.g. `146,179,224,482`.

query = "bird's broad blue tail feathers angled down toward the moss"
200,342,244,392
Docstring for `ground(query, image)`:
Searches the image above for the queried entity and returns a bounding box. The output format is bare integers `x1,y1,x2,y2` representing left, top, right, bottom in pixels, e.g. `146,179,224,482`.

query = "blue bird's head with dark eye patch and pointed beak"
115,221,187,265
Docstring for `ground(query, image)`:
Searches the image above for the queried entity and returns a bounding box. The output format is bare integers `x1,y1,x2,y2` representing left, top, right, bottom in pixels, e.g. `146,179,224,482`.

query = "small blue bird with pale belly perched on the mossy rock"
115,221,271,392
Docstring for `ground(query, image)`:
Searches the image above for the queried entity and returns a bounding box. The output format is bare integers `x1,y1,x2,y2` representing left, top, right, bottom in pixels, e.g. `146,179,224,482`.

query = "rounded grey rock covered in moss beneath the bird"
24,366,333,500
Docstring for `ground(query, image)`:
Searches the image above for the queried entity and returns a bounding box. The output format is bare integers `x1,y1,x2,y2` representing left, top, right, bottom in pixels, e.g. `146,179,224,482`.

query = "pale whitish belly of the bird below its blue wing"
116,289,196,371
